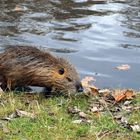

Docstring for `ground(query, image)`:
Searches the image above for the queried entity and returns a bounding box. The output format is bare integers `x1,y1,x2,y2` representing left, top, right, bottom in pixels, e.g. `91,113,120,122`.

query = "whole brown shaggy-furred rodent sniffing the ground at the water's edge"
0,46,83,93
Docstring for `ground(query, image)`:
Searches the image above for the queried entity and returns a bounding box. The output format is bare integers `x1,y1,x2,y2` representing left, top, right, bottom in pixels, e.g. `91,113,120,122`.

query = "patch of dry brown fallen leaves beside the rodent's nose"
68,77,140,133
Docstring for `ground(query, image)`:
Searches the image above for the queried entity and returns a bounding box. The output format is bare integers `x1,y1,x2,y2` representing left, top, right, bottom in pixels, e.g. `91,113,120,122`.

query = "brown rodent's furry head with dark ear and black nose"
32,54,83,94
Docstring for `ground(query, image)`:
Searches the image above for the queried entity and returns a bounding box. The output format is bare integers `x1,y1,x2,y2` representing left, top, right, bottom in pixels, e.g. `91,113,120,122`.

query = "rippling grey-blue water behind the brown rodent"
0,0,140,89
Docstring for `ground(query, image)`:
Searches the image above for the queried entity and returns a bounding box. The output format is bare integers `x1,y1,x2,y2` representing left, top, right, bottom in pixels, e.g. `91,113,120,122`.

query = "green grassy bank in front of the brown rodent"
0,93,140,140
